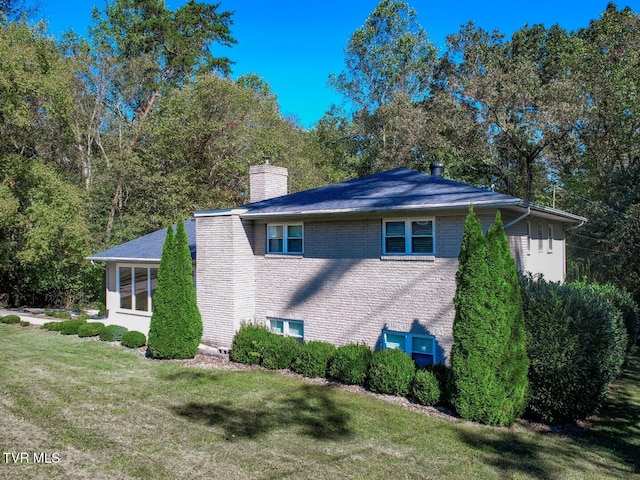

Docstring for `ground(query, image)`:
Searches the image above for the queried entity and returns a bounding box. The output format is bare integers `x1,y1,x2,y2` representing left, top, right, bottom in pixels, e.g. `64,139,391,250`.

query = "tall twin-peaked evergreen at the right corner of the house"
451,207,528,425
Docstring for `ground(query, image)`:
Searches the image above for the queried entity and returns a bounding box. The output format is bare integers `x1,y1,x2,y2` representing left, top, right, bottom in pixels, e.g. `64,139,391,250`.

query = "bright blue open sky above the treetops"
40,0,640,127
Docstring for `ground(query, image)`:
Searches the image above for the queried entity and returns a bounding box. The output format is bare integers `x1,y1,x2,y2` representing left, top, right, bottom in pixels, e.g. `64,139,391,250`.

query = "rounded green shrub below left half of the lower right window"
367,350,416,395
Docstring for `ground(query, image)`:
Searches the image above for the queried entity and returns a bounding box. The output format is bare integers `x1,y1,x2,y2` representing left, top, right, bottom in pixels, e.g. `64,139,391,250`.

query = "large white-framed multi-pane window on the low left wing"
116,264,158,313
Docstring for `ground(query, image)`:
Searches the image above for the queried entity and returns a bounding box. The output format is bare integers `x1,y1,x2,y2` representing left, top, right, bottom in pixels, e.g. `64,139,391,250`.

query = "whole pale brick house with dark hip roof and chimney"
89,164,585,363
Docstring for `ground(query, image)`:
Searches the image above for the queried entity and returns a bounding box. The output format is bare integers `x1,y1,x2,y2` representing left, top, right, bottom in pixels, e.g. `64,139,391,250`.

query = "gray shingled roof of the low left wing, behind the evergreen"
87,218,196,262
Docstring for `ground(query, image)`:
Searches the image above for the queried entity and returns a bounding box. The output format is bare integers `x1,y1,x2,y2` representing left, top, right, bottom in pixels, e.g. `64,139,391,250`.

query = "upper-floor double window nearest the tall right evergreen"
382,217,436,255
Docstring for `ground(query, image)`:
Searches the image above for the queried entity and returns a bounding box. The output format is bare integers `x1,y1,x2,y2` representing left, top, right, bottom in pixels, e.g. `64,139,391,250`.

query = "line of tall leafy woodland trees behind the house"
0,0,640,305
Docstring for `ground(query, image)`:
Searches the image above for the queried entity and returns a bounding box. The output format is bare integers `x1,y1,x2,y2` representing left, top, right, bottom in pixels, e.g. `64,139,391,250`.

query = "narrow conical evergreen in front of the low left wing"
147,220,202,358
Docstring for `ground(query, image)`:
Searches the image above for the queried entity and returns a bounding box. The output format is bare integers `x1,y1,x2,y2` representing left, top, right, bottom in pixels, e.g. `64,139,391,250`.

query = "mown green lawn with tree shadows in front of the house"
0,325,640,480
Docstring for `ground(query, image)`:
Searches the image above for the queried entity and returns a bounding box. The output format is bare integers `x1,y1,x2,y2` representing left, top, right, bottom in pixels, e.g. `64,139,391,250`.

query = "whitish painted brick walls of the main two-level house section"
196,211,564,361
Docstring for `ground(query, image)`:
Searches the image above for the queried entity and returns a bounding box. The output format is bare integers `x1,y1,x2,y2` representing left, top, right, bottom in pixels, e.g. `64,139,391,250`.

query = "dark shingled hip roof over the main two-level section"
235,167,523,217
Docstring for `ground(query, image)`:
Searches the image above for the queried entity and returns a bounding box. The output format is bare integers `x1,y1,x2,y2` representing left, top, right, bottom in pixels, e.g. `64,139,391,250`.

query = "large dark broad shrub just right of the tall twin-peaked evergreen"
521,277,627,423
